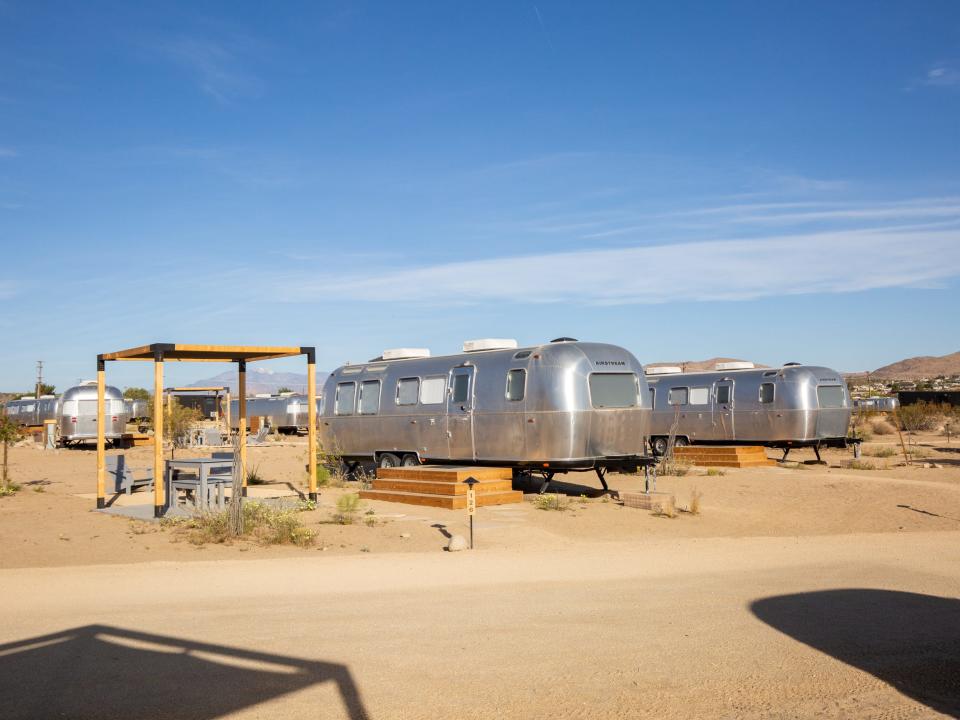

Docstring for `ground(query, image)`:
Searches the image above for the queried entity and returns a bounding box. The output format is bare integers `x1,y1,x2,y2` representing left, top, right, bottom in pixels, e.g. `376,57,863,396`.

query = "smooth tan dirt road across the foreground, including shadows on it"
0,532,960,719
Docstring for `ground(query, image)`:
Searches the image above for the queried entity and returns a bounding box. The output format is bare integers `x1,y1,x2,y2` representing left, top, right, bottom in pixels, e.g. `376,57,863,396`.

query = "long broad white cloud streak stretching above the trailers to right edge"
276,222,960,305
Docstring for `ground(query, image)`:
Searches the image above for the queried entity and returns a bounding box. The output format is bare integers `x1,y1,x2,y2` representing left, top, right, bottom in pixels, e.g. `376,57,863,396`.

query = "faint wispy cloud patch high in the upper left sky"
158,35,262,103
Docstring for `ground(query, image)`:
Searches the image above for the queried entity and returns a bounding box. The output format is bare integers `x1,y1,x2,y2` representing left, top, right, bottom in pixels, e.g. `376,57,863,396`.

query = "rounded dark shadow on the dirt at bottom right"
750,589,960,717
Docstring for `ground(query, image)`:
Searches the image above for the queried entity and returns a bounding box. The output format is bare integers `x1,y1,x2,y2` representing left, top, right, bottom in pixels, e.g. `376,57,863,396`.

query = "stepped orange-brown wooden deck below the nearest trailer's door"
360,465,523,510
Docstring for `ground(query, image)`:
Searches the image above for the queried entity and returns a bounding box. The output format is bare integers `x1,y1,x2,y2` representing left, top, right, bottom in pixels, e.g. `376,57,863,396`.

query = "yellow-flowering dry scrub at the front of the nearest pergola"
174,502,316,547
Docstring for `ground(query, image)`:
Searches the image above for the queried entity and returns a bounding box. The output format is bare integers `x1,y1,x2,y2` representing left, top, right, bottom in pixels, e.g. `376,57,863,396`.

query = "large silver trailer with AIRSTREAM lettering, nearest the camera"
319,338,653,488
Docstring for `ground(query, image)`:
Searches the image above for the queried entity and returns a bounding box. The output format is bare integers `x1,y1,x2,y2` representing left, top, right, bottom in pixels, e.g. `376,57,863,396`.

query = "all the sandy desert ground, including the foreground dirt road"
0,430,960,720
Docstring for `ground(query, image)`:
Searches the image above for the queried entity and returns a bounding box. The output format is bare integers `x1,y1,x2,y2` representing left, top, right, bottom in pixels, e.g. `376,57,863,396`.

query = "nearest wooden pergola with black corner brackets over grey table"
97,343,317,517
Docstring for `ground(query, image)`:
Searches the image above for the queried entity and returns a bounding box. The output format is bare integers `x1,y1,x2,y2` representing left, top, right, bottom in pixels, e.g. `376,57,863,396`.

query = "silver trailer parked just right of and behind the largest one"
647,362,858,458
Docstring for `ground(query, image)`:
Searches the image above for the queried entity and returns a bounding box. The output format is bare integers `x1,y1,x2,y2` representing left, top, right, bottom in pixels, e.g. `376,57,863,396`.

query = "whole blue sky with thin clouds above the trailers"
0,0,960,389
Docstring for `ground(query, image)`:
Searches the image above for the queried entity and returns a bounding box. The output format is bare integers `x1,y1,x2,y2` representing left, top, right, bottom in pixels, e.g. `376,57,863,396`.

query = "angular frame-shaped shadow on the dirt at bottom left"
0,625,368,720
